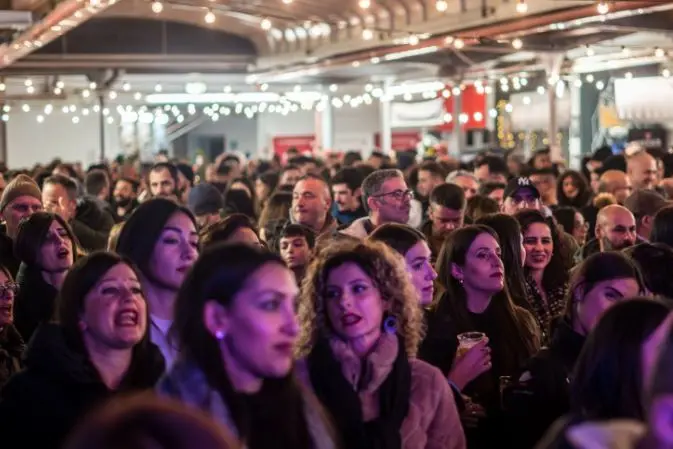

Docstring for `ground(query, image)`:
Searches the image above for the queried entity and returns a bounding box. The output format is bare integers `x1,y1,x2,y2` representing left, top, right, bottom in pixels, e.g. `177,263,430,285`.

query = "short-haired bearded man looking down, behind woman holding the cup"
421,183,467,260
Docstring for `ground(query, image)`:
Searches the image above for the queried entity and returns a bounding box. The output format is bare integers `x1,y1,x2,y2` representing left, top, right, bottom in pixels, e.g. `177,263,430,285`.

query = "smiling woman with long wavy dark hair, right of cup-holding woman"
515,210,568,344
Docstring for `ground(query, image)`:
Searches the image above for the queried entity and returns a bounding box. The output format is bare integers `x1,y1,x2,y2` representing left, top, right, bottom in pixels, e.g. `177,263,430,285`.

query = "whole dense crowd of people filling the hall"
0,145,673,449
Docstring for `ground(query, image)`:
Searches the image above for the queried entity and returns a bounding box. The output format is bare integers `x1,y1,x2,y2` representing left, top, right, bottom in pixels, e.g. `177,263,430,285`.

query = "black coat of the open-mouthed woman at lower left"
0,323,164,449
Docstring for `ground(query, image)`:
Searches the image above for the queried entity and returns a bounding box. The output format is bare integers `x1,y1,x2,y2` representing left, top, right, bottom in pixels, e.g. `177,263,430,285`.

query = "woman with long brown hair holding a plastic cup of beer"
419,225,540,448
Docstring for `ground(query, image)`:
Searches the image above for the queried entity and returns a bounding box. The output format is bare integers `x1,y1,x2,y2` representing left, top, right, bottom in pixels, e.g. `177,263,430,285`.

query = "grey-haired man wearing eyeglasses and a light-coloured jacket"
341,169,414,238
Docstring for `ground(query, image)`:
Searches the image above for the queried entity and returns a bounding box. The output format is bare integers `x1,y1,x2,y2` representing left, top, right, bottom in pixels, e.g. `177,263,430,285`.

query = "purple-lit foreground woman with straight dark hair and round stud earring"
158,244,335,449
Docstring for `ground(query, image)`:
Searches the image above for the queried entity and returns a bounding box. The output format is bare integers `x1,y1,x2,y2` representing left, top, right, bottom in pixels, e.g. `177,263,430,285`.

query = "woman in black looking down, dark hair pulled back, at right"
503,251,645,449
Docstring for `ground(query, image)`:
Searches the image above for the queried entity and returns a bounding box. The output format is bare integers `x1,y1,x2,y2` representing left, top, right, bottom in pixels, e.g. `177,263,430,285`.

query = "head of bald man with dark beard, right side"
596,204,636,252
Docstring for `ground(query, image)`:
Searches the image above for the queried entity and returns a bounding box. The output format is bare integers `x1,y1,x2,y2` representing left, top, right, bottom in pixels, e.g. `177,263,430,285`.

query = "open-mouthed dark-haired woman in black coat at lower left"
0,252,164,449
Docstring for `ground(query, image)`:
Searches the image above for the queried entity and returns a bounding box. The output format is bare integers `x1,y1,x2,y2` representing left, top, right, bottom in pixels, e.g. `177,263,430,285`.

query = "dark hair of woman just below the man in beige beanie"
14,211,79,266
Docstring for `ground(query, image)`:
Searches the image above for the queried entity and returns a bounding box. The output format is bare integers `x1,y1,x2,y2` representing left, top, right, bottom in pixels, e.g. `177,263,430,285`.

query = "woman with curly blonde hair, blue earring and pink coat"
299,240,465,449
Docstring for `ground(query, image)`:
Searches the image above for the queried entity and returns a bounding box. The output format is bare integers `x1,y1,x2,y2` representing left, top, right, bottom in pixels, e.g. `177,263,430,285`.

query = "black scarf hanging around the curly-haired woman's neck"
307,338,411,449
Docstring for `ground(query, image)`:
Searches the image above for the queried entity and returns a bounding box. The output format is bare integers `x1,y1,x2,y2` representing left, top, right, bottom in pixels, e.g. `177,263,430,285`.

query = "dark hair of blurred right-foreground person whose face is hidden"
570,298,671,420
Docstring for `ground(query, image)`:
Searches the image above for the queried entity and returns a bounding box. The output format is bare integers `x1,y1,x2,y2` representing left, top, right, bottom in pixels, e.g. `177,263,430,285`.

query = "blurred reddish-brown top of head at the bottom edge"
64,393,240,449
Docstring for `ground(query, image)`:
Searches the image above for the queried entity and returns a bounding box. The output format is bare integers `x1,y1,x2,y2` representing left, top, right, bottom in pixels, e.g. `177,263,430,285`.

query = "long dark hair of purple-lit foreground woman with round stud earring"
171,244,310,449
